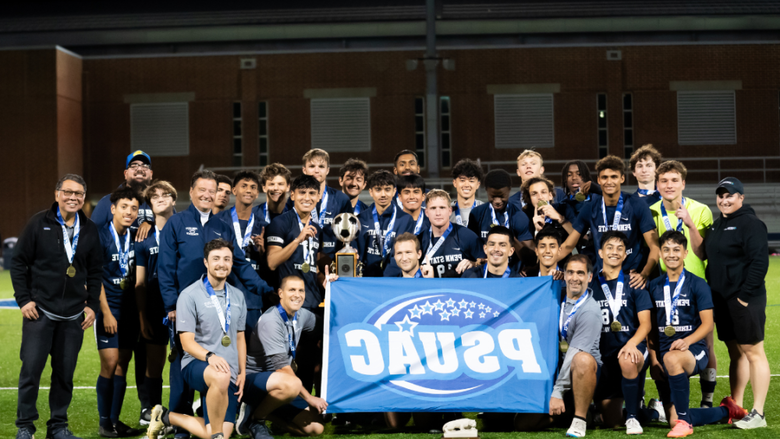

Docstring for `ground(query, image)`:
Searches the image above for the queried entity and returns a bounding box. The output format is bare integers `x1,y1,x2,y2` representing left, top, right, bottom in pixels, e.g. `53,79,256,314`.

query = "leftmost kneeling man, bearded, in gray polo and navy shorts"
146,239,246,439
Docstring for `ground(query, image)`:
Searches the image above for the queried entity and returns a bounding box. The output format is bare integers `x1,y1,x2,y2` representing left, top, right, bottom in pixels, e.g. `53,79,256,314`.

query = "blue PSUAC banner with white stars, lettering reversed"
322,276,561,413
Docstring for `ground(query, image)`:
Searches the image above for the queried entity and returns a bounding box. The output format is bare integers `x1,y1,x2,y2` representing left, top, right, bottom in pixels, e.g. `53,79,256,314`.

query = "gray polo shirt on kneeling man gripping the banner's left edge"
246,306,317,374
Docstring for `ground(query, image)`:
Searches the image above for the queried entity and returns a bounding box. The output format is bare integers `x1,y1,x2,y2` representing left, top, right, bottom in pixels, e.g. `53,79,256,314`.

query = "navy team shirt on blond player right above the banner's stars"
420,224,485,277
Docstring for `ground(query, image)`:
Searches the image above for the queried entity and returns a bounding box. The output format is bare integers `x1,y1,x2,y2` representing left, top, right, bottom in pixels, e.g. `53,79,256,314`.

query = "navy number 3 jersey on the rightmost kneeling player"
647,270,714,354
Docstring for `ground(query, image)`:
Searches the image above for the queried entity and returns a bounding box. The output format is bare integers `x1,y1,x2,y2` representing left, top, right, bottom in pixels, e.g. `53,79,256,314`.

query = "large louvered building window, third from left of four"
493,93,555,149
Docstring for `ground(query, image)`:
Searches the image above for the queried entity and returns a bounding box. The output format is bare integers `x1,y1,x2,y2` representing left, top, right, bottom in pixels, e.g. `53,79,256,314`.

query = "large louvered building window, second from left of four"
311,98,371,152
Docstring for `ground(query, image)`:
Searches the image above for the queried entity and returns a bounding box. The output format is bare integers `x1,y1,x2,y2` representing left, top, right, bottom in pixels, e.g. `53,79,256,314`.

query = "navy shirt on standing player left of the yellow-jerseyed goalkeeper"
573,192,655,273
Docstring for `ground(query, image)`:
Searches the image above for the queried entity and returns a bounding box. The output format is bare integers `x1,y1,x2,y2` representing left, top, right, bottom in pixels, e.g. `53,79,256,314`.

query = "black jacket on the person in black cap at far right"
704,204,769,302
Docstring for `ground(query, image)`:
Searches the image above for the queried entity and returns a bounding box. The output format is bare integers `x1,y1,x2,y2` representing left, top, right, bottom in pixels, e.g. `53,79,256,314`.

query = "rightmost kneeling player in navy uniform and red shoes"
648,230,747,437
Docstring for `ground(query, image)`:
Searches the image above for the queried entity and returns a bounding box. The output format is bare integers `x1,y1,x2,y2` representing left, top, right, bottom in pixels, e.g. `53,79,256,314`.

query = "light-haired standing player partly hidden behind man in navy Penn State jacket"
135,180,177,425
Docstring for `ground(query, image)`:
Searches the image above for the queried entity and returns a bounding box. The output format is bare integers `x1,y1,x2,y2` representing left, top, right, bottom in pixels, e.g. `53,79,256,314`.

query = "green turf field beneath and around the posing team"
0,257,780,439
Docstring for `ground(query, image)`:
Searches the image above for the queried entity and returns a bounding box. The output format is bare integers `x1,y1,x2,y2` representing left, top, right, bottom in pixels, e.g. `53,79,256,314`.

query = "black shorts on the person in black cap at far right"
712,293,766,344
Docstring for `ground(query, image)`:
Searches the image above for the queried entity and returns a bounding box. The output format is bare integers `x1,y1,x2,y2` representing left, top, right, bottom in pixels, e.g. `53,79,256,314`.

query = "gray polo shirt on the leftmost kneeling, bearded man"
176,275,246,381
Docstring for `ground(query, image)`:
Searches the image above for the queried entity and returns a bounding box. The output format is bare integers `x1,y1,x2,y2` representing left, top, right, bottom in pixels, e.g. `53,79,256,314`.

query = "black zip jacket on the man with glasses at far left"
11,203,103,317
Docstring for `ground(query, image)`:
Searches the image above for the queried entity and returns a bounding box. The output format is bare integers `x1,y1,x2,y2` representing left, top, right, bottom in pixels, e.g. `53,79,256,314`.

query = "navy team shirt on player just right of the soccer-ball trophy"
355,203,414,277
